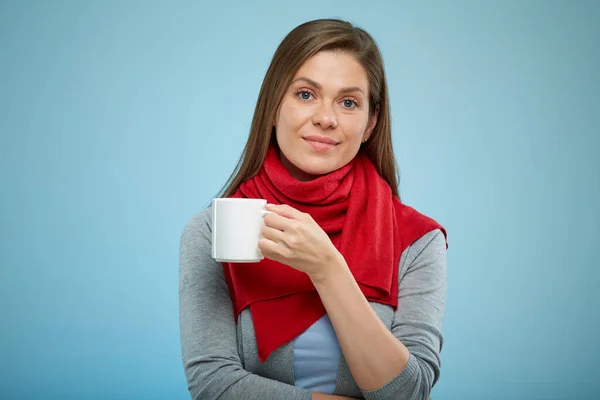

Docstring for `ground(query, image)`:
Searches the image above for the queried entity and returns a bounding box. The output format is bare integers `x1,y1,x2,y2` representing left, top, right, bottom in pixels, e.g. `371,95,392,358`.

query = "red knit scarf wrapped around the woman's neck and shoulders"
223,147,446,362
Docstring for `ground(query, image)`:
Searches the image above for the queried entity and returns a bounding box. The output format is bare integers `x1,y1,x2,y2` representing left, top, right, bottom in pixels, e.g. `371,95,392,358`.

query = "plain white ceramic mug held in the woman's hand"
212,198,268,263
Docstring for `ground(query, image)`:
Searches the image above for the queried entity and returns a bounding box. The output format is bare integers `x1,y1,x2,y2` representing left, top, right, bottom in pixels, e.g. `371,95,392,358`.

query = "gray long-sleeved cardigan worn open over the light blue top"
179,207,446,400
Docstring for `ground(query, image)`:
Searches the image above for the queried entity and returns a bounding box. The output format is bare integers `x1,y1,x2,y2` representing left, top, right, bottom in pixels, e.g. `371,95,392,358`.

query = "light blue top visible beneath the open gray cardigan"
294,315,342,394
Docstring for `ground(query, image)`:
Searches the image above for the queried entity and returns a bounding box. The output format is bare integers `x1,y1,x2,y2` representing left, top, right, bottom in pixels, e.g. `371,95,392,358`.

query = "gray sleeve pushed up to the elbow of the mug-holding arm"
363,230,446,400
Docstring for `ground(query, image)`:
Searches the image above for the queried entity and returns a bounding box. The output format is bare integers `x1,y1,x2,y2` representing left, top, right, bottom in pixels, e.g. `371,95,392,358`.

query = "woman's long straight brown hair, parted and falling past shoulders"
220,19,399,197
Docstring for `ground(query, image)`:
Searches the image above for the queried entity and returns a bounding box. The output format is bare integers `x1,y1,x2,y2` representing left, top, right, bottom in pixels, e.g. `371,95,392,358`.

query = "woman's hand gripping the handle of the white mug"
258,204,345,280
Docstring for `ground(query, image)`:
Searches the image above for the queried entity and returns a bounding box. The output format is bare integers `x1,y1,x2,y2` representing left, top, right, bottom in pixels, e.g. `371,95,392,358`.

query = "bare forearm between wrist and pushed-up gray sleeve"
313,258,410,390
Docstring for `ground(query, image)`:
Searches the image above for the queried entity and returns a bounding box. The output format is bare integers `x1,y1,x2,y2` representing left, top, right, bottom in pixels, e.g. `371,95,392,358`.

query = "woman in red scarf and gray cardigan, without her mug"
180,20,446,400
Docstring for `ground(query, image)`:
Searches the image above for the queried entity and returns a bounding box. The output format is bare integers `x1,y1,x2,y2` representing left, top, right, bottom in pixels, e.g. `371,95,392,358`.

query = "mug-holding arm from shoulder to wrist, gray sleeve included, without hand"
313,230,446,400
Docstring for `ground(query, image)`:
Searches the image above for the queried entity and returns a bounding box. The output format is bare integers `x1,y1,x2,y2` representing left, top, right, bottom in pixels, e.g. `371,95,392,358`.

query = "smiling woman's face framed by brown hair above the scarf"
275,51,377,181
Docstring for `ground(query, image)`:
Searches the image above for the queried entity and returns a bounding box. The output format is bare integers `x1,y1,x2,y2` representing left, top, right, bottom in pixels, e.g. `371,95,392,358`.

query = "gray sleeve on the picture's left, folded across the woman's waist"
179,210,311,400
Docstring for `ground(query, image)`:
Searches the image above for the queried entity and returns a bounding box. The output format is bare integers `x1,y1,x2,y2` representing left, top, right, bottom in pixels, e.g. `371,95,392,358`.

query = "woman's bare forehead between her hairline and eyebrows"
294,51,369,93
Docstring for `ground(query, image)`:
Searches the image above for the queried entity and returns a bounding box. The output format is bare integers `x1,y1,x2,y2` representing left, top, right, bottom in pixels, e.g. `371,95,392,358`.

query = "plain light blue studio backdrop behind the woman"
0,0,600,400
